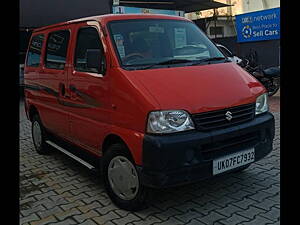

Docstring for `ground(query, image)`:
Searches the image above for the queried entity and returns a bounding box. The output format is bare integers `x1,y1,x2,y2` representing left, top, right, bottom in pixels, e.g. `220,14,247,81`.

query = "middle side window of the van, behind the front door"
45,30,70,70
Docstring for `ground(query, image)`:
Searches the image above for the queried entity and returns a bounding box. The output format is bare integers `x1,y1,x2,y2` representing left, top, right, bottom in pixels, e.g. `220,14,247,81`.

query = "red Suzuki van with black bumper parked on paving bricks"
24,14,274,210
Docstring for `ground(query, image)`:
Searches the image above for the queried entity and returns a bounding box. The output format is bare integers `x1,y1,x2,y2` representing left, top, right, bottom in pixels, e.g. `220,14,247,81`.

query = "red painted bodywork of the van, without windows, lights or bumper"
25,15,265,165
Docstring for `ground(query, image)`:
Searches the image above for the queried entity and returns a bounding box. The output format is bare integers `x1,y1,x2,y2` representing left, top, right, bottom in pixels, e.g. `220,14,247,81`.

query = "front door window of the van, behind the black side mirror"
74,27,105,73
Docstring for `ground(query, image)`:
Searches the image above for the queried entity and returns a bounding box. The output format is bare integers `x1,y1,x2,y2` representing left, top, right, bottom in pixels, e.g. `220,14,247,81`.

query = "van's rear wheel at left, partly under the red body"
31,114,49,155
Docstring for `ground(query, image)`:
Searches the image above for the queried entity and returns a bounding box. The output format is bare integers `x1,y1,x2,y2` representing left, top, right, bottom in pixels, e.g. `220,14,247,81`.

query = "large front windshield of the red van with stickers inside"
108,19,225,69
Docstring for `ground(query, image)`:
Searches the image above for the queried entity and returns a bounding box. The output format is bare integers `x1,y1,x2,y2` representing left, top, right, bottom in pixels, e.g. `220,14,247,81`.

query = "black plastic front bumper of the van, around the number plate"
137,113,275,188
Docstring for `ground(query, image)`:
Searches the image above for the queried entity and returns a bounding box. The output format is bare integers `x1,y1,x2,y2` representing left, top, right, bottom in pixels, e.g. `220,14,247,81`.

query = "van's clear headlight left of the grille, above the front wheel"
147,110,195,134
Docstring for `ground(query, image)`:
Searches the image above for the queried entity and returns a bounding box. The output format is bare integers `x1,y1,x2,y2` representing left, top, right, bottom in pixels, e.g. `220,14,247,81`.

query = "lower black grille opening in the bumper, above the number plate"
201,132,260,160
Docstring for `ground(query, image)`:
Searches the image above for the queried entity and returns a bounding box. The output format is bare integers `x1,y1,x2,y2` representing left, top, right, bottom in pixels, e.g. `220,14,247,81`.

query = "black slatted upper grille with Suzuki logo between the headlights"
192,103,255,131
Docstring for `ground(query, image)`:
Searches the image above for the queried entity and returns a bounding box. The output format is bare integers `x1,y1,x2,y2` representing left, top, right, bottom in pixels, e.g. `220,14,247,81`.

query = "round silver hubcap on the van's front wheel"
108,156,139,200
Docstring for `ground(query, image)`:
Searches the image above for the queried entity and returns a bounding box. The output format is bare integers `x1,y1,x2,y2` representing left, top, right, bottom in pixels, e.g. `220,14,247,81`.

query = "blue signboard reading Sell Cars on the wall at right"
236,8,280,42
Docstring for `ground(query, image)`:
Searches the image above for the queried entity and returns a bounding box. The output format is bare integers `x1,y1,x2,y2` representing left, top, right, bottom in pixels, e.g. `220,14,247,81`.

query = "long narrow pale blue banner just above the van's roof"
113,6,184,17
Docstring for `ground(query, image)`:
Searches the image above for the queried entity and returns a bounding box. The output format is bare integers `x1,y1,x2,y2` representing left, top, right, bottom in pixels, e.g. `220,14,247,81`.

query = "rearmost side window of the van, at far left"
26,34,44,67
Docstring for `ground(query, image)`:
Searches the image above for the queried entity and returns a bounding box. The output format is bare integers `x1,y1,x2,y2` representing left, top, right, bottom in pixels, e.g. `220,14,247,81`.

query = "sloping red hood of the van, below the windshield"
129,62,265,113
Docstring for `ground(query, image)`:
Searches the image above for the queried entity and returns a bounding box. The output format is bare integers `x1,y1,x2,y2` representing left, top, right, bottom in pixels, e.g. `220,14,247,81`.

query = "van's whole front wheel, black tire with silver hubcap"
102,144,148,211
